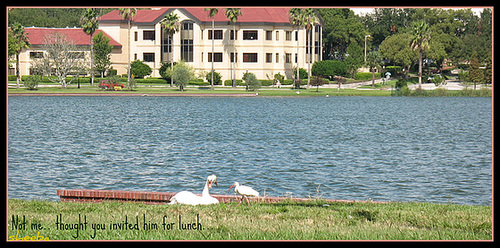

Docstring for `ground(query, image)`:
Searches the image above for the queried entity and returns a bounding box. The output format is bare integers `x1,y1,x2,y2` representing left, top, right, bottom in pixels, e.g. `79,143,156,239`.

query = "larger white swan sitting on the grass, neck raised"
169,175,219,206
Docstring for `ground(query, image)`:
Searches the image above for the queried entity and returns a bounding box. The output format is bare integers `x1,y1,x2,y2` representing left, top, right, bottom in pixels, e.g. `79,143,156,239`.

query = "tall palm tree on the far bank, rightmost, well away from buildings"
411,21,431,89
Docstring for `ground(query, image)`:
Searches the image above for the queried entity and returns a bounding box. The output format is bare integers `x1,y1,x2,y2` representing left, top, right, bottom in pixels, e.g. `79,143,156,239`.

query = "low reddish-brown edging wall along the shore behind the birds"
57,189,384,204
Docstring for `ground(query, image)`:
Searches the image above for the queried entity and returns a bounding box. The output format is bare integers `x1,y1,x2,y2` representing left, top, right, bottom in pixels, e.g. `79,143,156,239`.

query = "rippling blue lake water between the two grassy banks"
8,96,492,205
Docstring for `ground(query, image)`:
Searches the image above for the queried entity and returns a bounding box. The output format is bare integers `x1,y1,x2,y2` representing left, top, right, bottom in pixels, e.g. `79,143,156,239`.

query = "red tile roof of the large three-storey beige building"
101,7,290,23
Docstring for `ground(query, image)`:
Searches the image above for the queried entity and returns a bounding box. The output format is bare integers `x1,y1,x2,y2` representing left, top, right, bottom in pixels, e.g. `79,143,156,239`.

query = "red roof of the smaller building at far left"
24,28,121,47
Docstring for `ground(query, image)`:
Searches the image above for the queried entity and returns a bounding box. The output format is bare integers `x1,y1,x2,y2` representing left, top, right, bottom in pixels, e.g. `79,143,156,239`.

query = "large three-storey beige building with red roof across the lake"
99,8,322,80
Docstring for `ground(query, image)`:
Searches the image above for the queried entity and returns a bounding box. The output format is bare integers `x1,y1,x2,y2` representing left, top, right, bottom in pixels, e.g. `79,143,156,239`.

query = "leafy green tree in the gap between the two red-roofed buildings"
92,32,113,77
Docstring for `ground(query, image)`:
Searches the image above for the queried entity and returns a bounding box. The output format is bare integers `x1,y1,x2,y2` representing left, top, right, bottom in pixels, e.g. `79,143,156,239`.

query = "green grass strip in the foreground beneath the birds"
8,199,492,240
